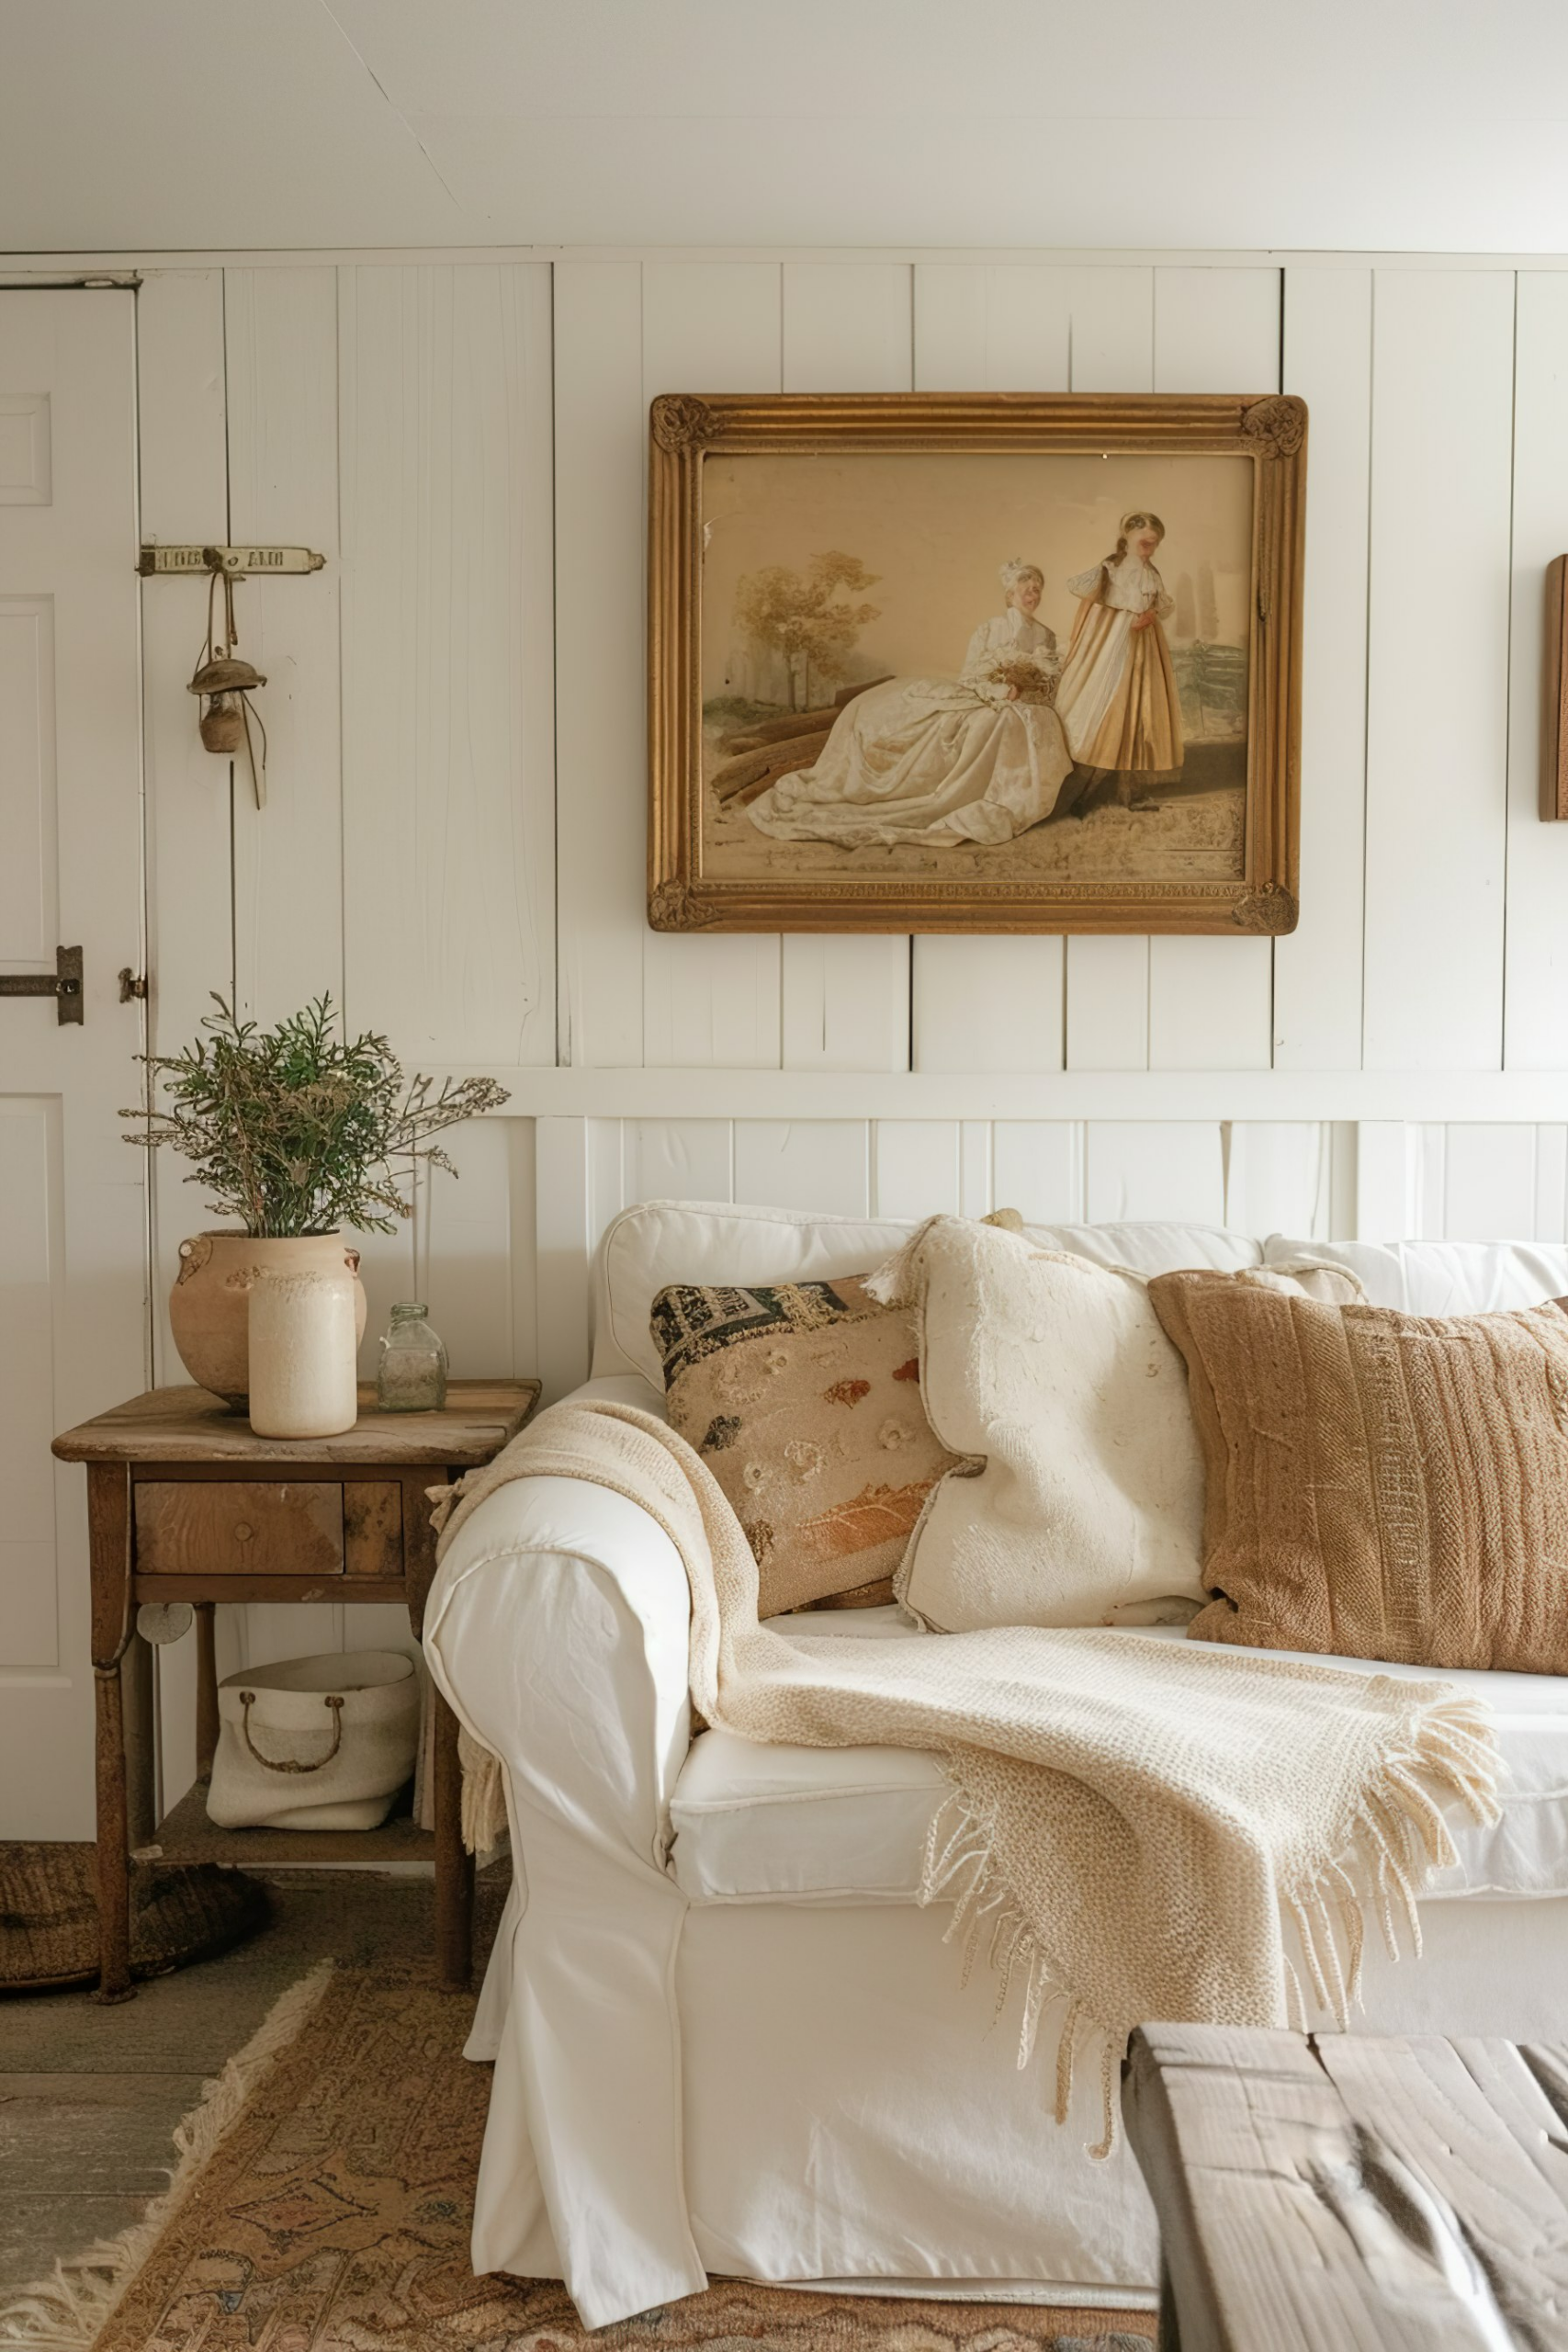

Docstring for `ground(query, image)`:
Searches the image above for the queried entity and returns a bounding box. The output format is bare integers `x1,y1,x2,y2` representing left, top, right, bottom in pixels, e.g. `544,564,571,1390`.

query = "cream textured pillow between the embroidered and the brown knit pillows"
877,1216,1227,1633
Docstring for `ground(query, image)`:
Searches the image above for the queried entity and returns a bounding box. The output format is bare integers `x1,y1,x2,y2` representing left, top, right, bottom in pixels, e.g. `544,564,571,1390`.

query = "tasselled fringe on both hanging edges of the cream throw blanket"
919,1696,1500,2159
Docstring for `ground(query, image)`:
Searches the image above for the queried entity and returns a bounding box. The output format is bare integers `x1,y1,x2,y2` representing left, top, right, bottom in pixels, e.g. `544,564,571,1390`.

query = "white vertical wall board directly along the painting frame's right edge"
1274,268,1373,1070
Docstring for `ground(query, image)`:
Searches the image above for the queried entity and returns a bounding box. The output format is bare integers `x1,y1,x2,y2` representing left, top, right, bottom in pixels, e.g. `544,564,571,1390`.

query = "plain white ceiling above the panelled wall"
0,0,1568,252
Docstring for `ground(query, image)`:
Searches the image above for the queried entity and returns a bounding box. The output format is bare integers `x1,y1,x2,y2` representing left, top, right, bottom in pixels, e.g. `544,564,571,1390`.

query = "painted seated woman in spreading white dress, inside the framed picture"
745,558,1072,849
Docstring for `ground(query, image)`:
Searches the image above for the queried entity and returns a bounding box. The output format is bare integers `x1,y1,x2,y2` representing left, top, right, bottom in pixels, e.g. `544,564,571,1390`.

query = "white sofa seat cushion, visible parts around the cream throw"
670,1609,1568,1903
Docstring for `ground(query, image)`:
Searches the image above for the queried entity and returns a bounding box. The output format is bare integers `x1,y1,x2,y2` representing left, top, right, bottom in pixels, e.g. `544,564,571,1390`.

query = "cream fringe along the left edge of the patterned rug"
0,1959,333,2352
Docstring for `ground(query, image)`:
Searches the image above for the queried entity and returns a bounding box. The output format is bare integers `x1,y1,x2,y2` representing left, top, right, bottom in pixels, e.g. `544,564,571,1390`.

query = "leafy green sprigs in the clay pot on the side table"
120,992,508,1235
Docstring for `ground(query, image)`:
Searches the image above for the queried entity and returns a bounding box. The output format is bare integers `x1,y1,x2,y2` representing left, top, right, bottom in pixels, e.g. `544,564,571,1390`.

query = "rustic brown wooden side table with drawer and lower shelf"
54,1381,538,2002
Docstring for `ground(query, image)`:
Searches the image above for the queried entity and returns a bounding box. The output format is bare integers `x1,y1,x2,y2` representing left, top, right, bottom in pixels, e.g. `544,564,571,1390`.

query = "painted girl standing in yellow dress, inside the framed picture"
1055,511,1185,807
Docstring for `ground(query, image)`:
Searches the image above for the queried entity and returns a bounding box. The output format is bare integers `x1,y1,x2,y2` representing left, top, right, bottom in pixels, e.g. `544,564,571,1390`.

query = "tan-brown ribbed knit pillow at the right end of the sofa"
1149,1272,1568,1675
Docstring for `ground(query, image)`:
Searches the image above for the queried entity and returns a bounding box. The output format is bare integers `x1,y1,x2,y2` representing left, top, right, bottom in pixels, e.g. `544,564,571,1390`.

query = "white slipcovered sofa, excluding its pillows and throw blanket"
425,1202,1568,2326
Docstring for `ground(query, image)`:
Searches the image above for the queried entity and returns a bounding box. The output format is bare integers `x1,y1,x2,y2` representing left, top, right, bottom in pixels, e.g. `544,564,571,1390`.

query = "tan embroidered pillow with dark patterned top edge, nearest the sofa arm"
651,1275,957,1616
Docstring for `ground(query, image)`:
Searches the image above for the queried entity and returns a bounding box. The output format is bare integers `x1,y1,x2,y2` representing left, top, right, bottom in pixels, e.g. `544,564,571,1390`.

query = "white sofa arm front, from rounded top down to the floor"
425,1477,707,2328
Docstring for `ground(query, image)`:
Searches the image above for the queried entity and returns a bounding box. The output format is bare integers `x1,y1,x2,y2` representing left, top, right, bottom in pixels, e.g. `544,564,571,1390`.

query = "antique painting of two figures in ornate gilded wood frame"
649,393,1307,933
